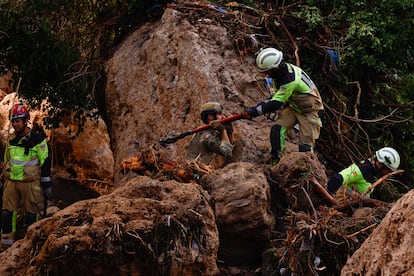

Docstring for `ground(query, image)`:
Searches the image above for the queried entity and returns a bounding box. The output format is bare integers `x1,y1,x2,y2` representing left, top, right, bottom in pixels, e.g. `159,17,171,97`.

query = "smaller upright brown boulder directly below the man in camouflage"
202,162,275,265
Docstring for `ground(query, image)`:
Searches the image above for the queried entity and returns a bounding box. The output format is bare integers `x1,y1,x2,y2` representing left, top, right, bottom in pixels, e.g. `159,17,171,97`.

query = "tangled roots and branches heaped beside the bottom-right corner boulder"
262,207,389,275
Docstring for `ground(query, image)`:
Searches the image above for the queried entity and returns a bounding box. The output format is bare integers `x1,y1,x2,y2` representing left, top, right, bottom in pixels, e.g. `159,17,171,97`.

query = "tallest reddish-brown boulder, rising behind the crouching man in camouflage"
105,8,270,183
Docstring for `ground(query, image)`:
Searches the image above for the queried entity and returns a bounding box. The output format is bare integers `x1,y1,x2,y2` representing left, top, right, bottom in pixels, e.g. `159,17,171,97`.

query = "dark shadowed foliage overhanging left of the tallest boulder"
0,0,154,126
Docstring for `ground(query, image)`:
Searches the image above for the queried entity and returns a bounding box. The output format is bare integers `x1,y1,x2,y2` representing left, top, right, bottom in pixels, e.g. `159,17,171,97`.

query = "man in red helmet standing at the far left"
1,103,52,250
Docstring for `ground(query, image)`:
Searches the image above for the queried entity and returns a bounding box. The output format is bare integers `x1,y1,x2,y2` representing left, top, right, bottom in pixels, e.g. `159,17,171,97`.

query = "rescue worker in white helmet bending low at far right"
328,147,400,202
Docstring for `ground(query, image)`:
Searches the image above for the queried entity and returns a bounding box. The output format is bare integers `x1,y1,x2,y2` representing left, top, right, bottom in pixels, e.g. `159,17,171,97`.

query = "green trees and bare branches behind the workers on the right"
298,0,414,179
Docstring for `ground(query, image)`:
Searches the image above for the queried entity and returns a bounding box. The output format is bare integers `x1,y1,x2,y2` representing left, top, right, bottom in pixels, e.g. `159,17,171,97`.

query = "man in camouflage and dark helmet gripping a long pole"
186,102,234,168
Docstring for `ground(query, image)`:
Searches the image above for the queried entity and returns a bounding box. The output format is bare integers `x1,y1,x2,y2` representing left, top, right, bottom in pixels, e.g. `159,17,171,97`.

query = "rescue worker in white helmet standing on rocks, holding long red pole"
243,48,323,165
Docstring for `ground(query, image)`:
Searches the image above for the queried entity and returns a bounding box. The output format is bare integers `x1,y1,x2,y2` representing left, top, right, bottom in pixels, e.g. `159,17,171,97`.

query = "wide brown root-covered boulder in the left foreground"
0,177,219,275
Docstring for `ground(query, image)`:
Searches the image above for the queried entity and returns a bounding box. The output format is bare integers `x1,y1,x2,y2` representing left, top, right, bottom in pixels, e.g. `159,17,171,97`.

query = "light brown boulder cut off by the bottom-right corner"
341,190,414,276
